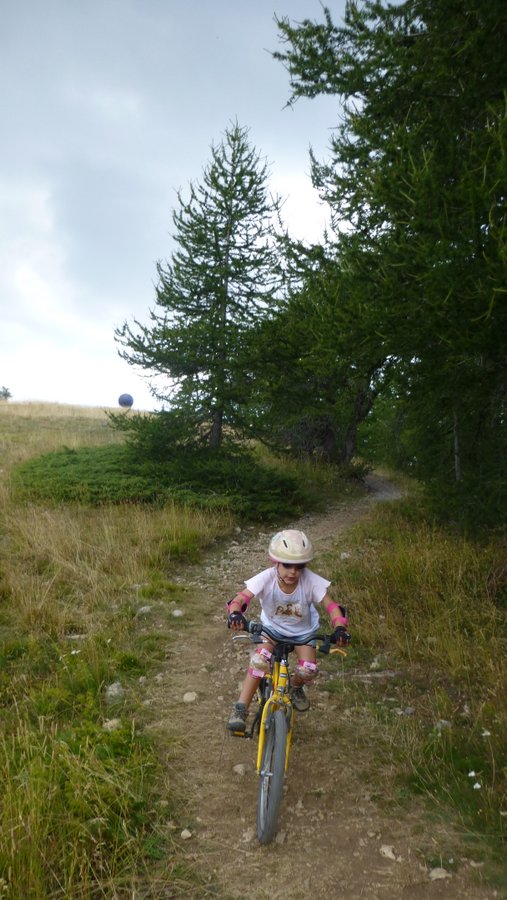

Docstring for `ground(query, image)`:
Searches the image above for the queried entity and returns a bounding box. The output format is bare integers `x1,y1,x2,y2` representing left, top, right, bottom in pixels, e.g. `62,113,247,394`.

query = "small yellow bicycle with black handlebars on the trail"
233,622,347,844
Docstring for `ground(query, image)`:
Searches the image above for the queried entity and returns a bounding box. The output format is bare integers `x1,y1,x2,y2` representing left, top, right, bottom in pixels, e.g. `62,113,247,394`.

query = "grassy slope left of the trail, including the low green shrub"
0,403,362,900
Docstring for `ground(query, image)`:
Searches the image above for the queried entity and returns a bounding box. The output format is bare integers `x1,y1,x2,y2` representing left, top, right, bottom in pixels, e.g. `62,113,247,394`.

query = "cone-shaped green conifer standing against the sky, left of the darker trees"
116,122,281,449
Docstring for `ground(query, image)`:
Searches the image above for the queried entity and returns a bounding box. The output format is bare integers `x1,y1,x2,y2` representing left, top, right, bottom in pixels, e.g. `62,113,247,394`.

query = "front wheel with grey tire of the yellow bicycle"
257,709,287,844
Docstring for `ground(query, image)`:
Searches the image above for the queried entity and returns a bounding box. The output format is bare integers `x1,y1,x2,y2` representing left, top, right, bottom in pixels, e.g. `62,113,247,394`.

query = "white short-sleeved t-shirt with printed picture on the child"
245,566,331,636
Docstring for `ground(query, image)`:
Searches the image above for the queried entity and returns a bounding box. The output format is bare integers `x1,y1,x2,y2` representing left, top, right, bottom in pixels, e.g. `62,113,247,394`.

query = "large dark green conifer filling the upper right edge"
275,0,507,520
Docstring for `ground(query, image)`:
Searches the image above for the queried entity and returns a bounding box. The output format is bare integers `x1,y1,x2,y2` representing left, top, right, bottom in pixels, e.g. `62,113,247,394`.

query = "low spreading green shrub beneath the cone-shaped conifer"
13,445,312,521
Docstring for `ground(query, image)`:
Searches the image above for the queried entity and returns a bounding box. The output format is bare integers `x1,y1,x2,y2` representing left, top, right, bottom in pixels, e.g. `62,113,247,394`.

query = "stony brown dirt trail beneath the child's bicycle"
144,477,498,900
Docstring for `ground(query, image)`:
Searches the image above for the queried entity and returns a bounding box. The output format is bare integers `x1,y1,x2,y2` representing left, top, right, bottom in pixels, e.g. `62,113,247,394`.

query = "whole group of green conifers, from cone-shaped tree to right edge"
116,0,507,527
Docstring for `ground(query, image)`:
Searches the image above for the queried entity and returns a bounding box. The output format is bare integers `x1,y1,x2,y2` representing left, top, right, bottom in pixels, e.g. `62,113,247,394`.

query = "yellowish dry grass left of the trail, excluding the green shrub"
0,403,230,900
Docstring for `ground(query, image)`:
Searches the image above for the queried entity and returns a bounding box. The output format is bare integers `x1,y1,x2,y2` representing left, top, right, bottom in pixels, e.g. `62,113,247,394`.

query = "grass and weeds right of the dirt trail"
328,498,507,872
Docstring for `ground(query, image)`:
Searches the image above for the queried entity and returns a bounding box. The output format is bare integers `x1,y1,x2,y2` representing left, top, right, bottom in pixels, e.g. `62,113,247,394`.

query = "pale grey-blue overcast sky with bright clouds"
0,0,345,409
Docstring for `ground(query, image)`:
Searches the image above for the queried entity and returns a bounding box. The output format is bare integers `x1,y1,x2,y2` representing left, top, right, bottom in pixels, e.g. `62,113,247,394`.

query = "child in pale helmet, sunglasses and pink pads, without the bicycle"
227,529,350,732
